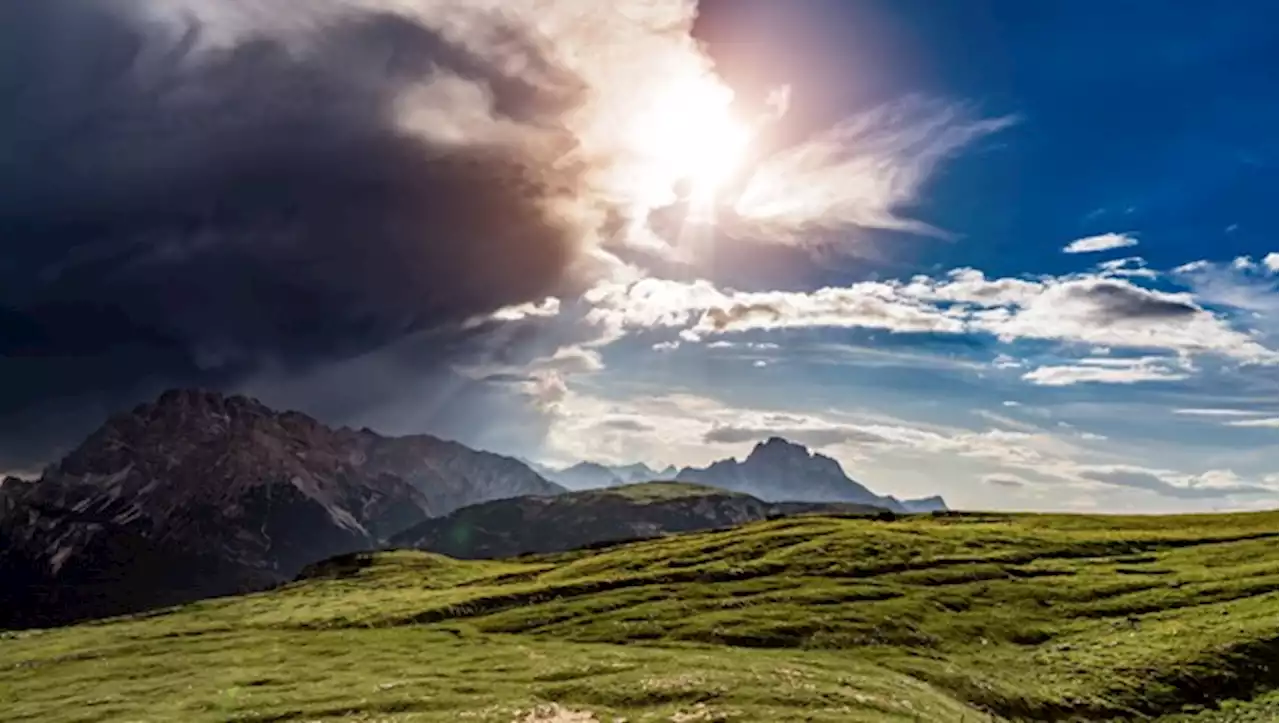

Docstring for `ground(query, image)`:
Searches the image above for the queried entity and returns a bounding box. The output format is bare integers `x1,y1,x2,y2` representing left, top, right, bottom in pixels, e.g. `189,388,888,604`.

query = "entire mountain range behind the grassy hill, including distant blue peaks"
0,390,946,627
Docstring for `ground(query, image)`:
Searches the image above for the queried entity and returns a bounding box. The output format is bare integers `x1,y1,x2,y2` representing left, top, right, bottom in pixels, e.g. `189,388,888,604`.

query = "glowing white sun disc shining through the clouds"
630,78,751,202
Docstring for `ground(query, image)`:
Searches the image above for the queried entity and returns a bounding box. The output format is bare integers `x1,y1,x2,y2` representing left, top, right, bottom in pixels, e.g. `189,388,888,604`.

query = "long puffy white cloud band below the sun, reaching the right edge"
586,269,1280,362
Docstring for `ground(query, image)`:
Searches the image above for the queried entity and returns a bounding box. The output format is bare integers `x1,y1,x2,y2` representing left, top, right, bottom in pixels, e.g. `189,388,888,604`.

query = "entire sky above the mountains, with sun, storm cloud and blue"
0,0,1280,512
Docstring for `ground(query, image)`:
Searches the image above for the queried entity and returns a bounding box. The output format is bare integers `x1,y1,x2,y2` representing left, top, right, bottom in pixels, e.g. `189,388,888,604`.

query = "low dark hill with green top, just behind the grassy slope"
392,482,882,558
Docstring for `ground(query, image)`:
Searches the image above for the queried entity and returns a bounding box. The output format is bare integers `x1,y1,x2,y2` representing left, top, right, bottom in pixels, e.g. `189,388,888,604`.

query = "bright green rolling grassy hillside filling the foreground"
0,513,1280,723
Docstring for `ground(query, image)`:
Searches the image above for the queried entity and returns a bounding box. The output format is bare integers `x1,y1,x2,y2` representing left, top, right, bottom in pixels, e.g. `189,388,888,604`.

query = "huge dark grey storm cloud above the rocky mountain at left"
0,0,593,470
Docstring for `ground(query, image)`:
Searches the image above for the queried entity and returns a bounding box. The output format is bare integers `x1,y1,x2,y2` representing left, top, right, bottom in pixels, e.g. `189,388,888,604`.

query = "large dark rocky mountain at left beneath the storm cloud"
0,390,561,626
